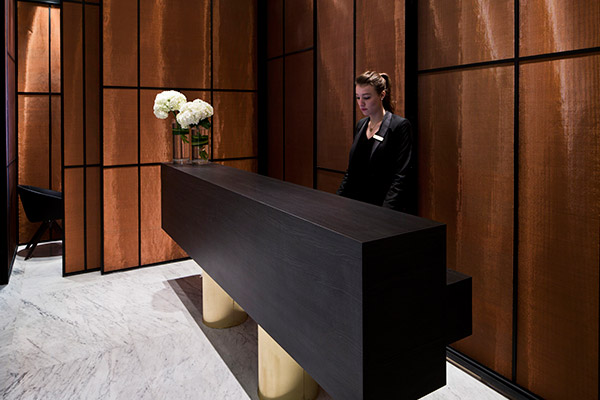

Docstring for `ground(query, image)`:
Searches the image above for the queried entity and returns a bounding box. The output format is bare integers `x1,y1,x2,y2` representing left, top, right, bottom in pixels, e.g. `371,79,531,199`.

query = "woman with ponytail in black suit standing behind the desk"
337,71,413,212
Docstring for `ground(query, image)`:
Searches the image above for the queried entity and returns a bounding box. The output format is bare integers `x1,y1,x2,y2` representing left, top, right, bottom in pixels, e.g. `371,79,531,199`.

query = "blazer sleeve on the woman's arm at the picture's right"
383,118,413,212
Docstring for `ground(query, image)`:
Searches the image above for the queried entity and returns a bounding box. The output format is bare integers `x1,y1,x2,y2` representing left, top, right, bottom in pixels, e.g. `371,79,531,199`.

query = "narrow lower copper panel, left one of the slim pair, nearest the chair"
63,168,85,274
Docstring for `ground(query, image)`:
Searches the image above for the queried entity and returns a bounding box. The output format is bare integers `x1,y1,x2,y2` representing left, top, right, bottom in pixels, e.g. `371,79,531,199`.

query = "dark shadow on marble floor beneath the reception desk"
168,275,333,400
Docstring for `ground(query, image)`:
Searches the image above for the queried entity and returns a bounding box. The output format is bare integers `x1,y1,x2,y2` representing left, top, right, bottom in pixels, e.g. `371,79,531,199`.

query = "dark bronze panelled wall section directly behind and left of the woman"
267,0,405,192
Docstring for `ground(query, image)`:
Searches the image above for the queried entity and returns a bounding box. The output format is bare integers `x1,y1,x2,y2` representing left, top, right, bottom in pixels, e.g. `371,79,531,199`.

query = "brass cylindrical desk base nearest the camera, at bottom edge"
258,326,319,400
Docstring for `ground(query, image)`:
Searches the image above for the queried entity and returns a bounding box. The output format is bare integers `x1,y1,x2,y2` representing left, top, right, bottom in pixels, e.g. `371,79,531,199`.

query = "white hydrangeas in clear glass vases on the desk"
154,90,214,163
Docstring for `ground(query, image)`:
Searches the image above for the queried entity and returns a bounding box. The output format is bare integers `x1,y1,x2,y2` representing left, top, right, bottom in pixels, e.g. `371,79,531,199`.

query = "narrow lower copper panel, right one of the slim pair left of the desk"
85,167,102,270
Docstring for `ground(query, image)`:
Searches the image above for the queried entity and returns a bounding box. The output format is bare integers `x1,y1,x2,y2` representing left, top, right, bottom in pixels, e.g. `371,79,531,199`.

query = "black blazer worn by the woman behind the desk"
337,111,413,212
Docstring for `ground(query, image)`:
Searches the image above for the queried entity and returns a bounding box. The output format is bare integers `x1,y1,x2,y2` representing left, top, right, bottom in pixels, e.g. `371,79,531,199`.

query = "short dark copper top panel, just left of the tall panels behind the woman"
284,0,314,53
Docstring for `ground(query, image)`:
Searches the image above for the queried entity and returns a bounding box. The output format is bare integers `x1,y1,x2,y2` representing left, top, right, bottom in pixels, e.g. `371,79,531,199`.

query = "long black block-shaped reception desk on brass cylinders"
161,163,470,400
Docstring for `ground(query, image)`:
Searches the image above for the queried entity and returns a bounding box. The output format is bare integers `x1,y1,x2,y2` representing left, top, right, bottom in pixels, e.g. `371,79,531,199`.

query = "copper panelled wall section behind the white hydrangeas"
103,0,258,272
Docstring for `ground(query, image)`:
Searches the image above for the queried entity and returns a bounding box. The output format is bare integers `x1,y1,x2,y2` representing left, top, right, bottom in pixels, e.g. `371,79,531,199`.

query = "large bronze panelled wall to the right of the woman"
418,0,600,399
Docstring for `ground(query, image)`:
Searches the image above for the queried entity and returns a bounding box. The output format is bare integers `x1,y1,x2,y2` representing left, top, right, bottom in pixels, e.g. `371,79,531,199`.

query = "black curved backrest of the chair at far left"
17,185,63,222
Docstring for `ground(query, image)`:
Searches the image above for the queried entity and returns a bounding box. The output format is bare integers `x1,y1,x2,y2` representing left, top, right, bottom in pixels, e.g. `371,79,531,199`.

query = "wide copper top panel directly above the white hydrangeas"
139,0,210,89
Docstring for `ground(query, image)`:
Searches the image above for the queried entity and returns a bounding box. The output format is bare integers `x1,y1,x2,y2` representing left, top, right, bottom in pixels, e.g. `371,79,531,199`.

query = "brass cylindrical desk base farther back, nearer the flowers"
202,271,248,328
